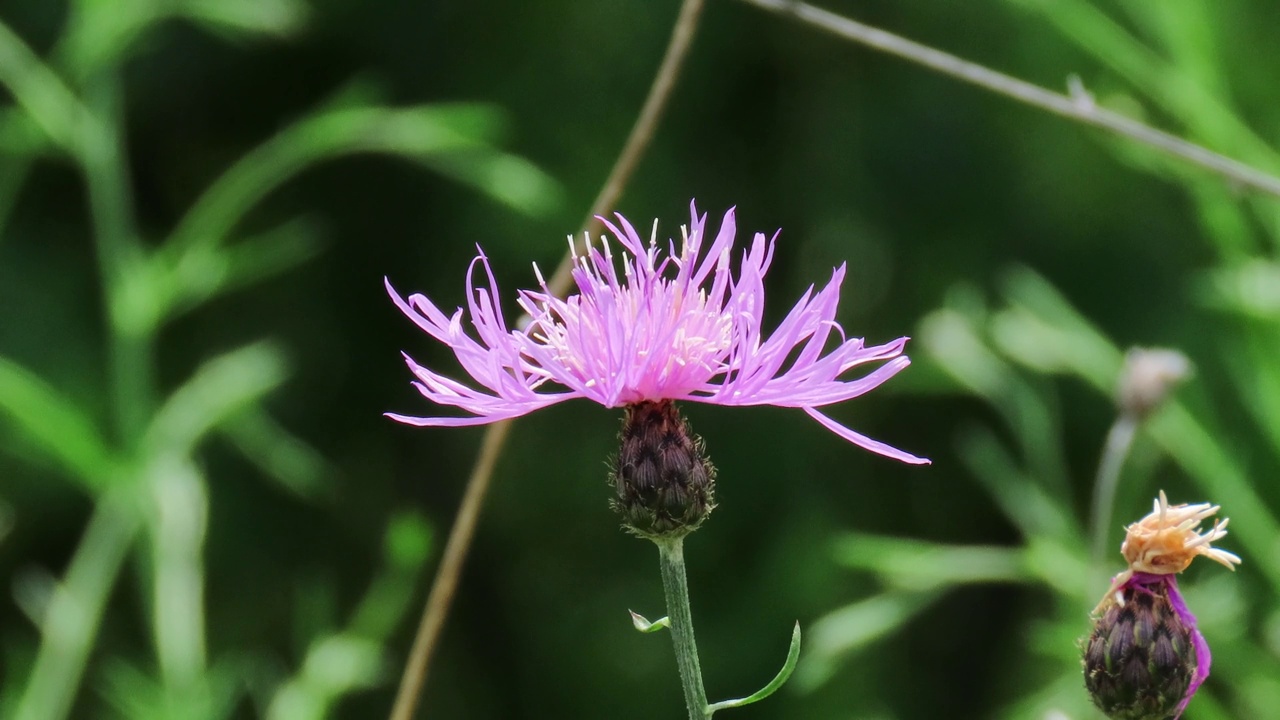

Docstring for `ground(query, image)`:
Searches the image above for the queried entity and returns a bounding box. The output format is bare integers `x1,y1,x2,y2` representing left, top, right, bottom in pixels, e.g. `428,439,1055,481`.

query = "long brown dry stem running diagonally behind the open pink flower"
390,0,704,720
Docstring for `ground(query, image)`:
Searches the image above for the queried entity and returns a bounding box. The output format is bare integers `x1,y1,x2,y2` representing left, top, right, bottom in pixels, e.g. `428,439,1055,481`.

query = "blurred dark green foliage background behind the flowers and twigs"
0,0,1280,720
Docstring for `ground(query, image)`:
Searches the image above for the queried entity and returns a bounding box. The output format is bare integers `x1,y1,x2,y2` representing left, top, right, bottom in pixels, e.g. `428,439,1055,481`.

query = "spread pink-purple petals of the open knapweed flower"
387,198,928,462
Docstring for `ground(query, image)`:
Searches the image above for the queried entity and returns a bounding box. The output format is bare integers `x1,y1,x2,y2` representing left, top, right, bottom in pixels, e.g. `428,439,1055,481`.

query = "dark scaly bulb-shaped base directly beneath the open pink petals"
612,400,716,538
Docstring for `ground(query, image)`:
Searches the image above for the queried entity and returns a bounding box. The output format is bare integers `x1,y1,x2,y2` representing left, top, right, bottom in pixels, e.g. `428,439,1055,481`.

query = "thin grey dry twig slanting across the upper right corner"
742,0,1280,197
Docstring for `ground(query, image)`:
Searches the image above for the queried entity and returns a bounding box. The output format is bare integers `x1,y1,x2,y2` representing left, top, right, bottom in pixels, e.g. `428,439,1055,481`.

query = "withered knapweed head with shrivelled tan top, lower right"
1084,492,1240,720
